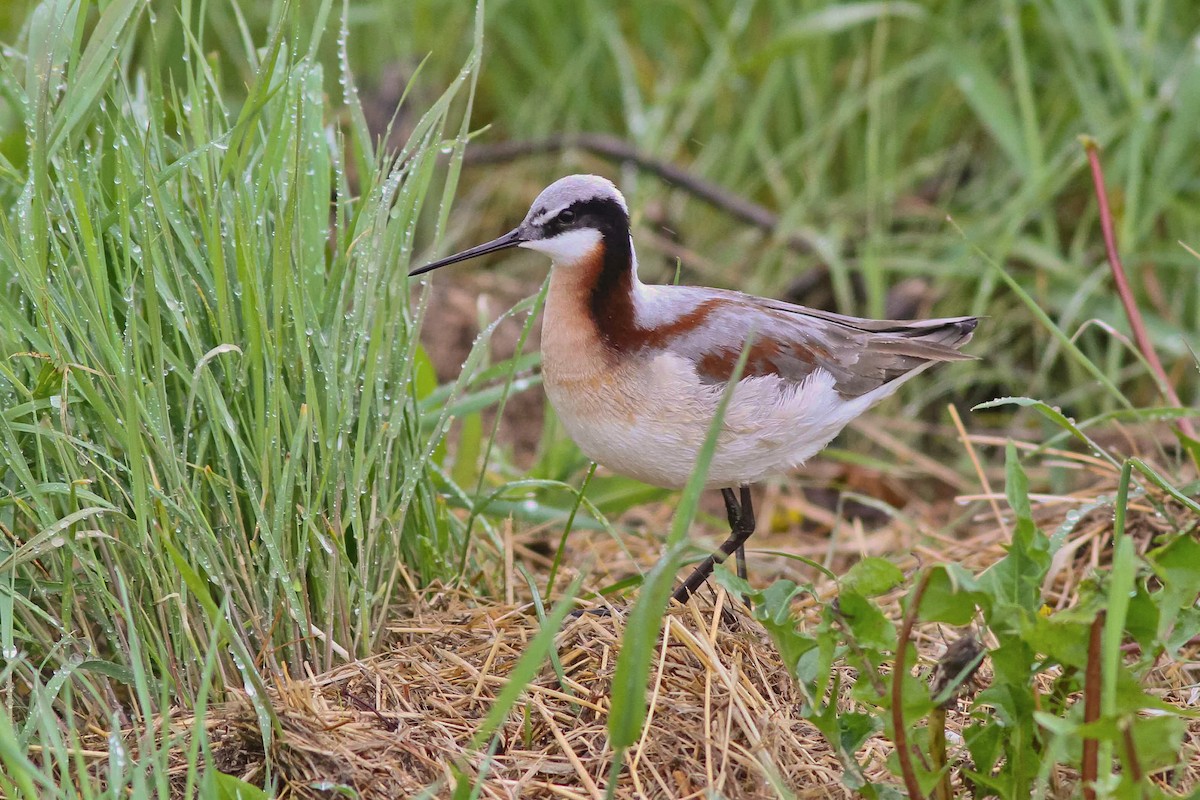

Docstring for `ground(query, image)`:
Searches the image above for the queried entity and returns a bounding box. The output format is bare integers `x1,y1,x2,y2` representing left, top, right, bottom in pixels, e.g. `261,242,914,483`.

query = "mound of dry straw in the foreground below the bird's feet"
187,593,886,798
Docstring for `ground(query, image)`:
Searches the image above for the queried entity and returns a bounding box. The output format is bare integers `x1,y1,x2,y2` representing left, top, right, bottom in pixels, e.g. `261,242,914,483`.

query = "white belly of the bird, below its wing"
544,353,873,488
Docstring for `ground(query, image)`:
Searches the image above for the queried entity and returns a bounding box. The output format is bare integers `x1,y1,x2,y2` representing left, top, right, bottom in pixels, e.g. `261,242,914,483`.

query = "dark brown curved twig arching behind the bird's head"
463,133,814,253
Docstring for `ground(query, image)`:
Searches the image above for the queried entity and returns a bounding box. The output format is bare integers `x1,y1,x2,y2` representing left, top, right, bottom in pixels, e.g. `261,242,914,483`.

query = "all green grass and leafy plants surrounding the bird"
0,0,1200,798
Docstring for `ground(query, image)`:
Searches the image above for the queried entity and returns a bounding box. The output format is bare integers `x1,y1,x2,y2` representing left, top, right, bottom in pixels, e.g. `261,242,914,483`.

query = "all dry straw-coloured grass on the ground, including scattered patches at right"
84,431,1200,799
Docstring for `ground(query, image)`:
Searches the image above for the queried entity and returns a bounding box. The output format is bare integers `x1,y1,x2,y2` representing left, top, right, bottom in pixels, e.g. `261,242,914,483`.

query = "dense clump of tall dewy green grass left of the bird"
0,0,482,796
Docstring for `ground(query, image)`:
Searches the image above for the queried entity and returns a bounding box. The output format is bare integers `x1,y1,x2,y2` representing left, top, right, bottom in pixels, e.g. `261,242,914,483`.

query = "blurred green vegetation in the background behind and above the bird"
9,0,1200,415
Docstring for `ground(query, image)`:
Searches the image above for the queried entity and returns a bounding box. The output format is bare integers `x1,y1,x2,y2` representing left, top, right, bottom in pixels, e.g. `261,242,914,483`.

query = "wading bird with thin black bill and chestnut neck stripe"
409,175,978,603
